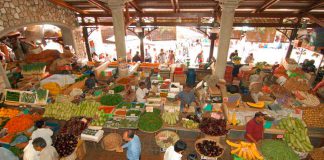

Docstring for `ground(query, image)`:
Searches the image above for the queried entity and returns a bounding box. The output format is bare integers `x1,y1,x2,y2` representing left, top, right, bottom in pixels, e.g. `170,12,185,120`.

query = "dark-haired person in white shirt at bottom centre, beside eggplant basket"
163,140,187,160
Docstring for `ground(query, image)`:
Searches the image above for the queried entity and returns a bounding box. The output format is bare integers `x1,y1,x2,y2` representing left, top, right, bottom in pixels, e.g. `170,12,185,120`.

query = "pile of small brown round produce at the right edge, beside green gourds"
302,107,324,128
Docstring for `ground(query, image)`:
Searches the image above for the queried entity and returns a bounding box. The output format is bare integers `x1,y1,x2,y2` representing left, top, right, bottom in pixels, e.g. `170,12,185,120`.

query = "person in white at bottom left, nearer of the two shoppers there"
23,137,59,160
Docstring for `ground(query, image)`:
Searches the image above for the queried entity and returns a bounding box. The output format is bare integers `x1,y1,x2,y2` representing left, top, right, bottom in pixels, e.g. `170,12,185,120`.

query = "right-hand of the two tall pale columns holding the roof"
216,0,240,79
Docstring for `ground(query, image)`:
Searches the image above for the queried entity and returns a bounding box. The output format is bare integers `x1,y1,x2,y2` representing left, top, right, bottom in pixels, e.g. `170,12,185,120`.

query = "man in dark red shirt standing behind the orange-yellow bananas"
245,112,266,143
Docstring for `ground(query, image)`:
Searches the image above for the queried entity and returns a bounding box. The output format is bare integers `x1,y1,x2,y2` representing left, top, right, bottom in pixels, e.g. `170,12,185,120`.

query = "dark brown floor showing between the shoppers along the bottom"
85,130,231,160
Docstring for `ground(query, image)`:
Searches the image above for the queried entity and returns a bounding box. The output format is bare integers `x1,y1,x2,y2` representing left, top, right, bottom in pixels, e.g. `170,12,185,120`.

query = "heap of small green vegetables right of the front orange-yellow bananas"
261,140,299,160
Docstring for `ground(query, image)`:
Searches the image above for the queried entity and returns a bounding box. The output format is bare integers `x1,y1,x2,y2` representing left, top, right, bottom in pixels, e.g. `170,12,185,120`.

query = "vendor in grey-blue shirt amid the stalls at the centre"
176,85,199,112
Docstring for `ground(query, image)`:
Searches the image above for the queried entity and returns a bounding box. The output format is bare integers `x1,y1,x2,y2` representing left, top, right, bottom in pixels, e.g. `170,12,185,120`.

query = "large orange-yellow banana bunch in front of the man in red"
226,140,264,160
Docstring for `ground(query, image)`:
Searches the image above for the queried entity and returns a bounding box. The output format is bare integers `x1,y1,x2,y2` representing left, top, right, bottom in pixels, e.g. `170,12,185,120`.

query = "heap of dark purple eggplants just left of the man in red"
199,118,228,136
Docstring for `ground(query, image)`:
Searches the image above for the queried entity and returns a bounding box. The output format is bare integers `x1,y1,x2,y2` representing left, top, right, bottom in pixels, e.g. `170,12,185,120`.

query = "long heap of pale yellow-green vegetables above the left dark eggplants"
43,101,100,120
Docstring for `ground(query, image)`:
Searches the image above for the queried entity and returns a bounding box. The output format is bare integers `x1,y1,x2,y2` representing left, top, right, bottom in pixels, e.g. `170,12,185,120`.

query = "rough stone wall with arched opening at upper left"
0,0,85,57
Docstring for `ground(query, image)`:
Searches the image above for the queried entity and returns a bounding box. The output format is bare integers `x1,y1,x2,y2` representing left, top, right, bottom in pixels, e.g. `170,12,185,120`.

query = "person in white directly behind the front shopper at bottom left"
31,120,53,146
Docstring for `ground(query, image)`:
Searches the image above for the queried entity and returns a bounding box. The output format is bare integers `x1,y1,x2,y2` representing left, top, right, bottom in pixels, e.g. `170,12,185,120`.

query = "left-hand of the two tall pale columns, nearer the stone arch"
108,0,126,58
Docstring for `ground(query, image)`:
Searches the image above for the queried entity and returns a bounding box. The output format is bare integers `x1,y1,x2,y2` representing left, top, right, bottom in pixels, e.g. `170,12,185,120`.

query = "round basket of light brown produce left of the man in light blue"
102,133,123,151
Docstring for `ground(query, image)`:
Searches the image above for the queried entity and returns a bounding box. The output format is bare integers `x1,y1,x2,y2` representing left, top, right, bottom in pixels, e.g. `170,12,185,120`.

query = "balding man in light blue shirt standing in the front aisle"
122,130,142,160
